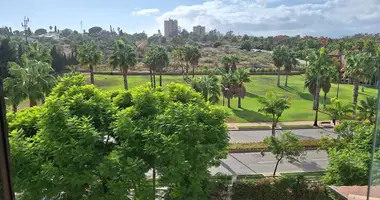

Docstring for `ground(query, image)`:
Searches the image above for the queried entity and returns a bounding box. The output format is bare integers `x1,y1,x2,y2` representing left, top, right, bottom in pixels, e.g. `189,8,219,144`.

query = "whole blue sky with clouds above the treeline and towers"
0,0,380,37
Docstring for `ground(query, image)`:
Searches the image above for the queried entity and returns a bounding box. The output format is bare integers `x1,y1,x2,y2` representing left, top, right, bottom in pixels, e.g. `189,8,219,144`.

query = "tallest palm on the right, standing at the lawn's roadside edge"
305,48,336,126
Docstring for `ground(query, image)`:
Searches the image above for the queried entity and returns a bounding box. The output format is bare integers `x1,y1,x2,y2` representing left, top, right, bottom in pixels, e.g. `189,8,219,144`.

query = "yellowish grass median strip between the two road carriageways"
228,139,320,152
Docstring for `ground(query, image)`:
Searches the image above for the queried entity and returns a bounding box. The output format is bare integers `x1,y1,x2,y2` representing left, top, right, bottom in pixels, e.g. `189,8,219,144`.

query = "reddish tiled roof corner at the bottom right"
329,186,380,199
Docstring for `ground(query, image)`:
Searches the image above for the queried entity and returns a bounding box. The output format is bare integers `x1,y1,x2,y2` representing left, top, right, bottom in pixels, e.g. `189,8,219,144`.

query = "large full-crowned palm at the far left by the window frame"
4,56,56,109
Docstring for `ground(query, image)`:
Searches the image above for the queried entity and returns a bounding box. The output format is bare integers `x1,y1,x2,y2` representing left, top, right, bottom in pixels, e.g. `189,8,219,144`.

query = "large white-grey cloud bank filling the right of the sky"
157,0,380,36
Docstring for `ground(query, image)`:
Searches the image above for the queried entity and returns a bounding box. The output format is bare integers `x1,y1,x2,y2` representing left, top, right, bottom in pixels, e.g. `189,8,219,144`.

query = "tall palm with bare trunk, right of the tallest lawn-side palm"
344,53,370,111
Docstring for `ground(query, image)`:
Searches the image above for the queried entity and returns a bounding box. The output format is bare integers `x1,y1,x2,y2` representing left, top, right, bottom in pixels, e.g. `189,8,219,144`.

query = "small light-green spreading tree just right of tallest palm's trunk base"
325,98,352,125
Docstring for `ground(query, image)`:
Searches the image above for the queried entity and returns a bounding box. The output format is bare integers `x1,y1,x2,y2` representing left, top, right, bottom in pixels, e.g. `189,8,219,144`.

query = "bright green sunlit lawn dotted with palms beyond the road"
87,75,377,123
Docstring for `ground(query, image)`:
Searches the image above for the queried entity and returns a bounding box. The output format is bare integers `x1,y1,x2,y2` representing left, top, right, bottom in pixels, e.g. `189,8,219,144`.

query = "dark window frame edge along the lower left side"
0,53,15,200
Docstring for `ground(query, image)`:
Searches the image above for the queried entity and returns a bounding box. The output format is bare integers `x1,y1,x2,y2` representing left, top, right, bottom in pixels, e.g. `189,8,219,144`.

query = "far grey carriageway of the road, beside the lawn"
229,129,336,143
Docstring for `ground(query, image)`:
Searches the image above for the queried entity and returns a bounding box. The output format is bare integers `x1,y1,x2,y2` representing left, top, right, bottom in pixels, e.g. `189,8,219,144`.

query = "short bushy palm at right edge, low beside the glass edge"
358,97,377,123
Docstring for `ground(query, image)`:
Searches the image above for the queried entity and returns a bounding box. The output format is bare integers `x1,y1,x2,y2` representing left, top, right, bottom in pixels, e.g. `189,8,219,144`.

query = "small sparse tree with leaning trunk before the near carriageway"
264,131,305,177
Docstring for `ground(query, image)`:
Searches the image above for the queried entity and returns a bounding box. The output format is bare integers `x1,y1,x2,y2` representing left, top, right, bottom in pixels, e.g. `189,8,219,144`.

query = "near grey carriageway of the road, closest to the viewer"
210,151,328,175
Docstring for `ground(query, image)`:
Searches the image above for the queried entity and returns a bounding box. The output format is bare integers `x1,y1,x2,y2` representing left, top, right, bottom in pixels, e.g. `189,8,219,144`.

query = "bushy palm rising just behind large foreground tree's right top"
191,74,220,104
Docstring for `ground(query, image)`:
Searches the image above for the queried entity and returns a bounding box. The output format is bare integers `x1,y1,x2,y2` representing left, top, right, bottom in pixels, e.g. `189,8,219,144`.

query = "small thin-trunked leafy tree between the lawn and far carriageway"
259,91,290,136
